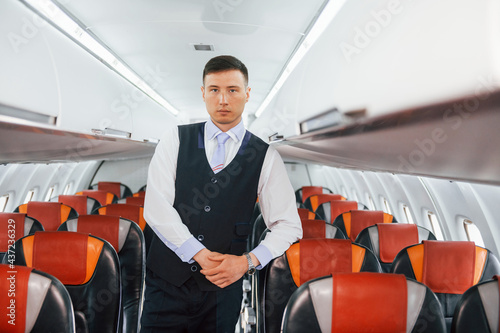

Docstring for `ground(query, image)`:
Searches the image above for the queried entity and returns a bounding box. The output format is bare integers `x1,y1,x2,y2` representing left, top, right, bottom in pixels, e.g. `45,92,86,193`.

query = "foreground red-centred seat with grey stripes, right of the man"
281,273,446,333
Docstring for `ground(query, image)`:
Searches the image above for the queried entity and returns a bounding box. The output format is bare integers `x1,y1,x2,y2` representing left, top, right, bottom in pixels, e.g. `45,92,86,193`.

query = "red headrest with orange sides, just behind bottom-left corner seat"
22,231,104,285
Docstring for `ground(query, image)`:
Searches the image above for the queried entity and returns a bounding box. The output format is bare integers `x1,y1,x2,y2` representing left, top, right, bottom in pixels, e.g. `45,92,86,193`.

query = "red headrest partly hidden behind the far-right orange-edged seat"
376,223,418,263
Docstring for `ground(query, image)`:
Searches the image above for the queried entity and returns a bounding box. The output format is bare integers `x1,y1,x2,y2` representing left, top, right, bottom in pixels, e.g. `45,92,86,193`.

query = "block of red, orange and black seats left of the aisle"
0,182,147,332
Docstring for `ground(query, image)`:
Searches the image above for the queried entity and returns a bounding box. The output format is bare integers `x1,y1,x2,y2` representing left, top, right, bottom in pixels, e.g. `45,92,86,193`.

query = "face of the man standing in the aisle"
201,69,250,132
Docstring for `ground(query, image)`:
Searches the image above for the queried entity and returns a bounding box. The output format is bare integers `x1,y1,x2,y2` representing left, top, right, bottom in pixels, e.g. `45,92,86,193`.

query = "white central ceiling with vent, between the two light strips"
53,0,327,122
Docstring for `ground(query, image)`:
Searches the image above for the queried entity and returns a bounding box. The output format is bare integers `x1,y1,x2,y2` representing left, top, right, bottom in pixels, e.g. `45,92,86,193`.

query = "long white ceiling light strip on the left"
21,0,179,116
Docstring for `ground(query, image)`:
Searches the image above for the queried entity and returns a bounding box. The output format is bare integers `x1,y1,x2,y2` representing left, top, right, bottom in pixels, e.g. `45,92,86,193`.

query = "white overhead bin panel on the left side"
0,1,179,140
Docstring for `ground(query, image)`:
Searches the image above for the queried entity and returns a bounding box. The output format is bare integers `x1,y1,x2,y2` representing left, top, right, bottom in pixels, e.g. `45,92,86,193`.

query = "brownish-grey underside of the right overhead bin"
275,91,500,184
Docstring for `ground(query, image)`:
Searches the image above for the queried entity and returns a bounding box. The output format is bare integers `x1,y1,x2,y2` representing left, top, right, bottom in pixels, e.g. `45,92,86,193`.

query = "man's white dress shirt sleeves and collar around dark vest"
144,120,302,269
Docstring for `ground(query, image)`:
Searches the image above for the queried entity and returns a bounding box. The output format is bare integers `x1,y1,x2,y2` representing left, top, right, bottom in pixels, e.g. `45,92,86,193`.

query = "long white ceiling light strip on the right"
255,0,346,117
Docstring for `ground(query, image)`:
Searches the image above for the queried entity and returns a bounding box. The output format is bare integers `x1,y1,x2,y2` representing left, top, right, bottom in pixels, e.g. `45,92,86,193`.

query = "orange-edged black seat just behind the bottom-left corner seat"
4,231,121,333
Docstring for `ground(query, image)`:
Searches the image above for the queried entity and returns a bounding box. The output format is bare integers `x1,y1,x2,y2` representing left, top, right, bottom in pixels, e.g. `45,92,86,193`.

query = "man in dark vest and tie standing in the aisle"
141,56,302,333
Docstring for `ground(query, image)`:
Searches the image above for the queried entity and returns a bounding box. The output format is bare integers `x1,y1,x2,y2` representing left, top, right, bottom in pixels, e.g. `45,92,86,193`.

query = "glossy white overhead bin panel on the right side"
252,0,500,132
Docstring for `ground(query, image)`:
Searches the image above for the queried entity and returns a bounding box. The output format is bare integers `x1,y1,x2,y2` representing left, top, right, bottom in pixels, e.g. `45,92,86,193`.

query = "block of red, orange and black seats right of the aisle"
242,185,500,332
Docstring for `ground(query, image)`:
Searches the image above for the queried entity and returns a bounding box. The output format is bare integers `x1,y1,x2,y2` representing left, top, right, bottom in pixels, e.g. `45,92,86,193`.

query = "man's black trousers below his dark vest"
141,270,243,333
